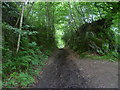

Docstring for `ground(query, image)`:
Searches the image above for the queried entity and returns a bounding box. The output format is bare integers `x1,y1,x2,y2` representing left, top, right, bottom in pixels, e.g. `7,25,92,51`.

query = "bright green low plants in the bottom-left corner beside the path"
3,72,34,88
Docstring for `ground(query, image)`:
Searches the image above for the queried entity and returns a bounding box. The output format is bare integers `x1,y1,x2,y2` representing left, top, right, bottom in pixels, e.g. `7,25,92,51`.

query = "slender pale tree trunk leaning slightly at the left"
16,3,24,54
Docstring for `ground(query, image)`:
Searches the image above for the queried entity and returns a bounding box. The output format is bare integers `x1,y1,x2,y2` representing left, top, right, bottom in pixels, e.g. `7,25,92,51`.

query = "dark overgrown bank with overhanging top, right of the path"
63,3,120,61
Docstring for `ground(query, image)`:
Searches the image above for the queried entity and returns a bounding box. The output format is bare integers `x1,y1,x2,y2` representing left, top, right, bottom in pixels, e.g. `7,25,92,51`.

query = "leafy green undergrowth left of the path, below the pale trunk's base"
2,24,51,88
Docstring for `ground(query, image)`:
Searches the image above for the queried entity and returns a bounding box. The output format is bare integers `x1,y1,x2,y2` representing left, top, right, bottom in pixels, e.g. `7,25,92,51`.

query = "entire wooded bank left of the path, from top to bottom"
2,2,56,88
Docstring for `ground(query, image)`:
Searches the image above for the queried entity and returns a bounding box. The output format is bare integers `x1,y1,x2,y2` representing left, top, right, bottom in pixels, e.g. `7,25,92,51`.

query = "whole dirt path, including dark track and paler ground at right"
35,49,118,88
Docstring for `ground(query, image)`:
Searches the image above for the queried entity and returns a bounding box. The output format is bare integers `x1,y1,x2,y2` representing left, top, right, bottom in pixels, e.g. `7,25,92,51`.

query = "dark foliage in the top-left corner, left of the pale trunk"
2,2,21,26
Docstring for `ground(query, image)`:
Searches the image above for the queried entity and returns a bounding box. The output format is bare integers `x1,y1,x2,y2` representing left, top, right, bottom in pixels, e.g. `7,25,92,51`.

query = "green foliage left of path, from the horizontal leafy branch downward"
2,12,51,88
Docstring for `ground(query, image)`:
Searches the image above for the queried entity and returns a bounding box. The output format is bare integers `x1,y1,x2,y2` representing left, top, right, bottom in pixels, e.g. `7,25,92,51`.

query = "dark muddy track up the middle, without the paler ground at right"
36,49,87,88
